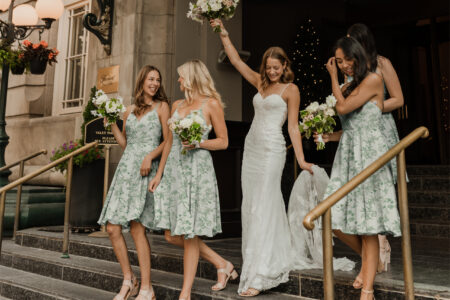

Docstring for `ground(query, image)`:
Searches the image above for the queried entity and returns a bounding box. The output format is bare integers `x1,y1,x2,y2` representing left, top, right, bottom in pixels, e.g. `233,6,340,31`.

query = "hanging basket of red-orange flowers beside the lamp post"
22,40,59,74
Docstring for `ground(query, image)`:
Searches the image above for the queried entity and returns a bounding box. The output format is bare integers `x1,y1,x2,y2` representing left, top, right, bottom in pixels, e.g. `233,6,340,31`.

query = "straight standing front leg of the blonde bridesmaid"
180,237,200,300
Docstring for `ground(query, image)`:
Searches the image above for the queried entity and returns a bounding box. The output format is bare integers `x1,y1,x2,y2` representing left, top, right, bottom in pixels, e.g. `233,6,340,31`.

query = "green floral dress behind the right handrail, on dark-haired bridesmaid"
324,101,401,236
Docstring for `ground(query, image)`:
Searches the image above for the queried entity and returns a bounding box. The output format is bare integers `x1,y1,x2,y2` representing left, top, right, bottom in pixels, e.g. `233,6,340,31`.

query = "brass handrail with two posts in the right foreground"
303,126,429,300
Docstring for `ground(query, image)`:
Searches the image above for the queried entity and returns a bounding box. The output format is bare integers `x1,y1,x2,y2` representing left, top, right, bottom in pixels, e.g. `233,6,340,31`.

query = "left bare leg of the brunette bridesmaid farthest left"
106,223,133,296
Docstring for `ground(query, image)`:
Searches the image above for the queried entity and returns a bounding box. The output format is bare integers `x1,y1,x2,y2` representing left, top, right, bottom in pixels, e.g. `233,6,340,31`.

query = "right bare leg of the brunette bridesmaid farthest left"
130,221,151,290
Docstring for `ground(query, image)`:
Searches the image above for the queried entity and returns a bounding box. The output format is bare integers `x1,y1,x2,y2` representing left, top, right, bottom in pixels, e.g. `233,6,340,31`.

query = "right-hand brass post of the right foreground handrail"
397,150,414,300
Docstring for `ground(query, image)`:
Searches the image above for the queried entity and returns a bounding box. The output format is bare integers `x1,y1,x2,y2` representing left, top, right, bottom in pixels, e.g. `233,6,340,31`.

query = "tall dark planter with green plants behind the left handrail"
50,87,105,231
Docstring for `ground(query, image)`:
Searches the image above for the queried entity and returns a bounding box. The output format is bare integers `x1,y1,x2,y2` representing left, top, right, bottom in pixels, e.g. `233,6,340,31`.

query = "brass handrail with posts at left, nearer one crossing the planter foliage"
0,142,98,258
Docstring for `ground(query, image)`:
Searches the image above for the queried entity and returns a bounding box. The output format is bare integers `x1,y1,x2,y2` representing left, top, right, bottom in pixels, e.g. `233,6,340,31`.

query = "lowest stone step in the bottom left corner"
0,266,114,300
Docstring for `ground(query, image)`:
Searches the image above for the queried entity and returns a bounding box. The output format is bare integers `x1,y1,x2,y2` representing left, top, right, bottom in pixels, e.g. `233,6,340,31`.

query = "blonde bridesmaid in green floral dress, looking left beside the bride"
149,60,237,300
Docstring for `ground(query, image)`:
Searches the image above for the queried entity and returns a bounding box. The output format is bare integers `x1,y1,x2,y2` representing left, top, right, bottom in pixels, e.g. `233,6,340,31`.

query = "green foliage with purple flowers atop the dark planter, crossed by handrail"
50,140,103,173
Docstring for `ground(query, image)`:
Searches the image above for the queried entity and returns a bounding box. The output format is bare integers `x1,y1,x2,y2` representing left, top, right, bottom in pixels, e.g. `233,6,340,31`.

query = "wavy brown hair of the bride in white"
259,47,294,90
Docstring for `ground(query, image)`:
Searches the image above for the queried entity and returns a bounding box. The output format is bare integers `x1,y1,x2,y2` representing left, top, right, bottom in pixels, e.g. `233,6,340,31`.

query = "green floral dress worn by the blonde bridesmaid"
154,104,222,239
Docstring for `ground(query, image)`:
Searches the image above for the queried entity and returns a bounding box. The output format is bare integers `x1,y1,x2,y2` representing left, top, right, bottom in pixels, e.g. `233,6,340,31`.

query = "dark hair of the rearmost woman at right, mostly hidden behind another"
347,23,378,72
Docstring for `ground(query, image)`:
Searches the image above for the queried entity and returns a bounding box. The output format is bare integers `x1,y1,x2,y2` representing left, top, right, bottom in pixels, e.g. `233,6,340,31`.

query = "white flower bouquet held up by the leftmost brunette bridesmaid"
91,90,126,130
